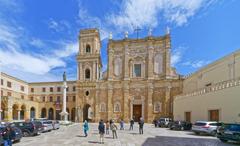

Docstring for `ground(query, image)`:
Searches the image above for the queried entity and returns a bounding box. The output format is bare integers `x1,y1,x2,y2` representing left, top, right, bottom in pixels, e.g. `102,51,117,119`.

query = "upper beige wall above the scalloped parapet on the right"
183,50,240,93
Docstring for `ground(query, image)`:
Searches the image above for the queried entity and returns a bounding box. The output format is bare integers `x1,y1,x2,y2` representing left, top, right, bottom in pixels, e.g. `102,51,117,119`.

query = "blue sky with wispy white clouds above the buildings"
0,0,240,82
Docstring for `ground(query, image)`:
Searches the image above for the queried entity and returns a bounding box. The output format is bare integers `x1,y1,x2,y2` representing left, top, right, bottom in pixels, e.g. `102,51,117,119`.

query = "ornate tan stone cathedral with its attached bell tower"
76,29,182,122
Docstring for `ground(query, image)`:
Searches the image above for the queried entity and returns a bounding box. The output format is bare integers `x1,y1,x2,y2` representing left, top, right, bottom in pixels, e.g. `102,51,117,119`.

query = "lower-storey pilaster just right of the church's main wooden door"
147,83,153,122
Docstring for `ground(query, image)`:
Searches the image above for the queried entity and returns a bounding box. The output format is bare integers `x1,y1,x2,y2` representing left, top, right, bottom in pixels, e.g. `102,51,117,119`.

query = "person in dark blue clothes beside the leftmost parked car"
3,126,15,146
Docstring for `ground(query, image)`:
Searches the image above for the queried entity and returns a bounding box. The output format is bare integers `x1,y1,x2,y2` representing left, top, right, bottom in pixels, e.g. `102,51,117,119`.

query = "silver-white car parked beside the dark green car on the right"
192,121,222,136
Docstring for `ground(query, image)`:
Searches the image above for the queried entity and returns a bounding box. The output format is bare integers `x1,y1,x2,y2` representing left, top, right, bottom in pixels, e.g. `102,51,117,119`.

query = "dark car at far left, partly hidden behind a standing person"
0,126,23,144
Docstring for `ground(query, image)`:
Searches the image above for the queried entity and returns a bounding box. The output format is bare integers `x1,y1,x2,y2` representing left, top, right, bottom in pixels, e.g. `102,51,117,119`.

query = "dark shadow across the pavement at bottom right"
142,136,234,146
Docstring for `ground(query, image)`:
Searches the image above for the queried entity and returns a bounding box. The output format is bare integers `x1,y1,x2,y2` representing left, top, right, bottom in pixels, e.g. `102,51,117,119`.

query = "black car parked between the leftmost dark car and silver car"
11,122,39,137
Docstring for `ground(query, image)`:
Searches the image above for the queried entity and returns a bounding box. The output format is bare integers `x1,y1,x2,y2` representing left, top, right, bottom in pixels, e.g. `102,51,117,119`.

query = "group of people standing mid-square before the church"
80,118,144,144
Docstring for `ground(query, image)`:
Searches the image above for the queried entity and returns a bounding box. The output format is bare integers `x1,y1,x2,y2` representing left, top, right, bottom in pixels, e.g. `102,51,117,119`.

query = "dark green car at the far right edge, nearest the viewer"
217,124,240,143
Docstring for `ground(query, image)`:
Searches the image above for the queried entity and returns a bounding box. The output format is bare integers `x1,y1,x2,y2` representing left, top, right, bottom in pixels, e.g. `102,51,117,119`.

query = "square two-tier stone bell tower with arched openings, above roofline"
77,29,102,82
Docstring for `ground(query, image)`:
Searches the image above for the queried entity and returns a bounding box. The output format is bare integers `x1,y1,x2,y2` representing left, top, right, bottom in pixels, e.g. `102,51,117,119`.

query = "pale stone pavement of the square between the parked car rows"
14,124,237,146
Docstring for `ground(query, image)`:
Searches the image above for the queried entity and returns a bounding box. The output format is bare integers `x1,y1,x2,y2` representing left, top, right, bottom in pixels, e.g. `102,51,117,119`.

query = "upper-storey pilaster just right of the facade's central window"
147,43,154,79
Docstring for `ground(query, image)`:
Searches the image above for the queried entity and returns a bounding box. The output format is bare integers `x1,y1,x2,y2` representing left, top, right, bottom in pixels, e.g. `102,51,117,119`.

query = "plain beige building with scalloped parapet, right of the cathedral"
174,50,240,122
